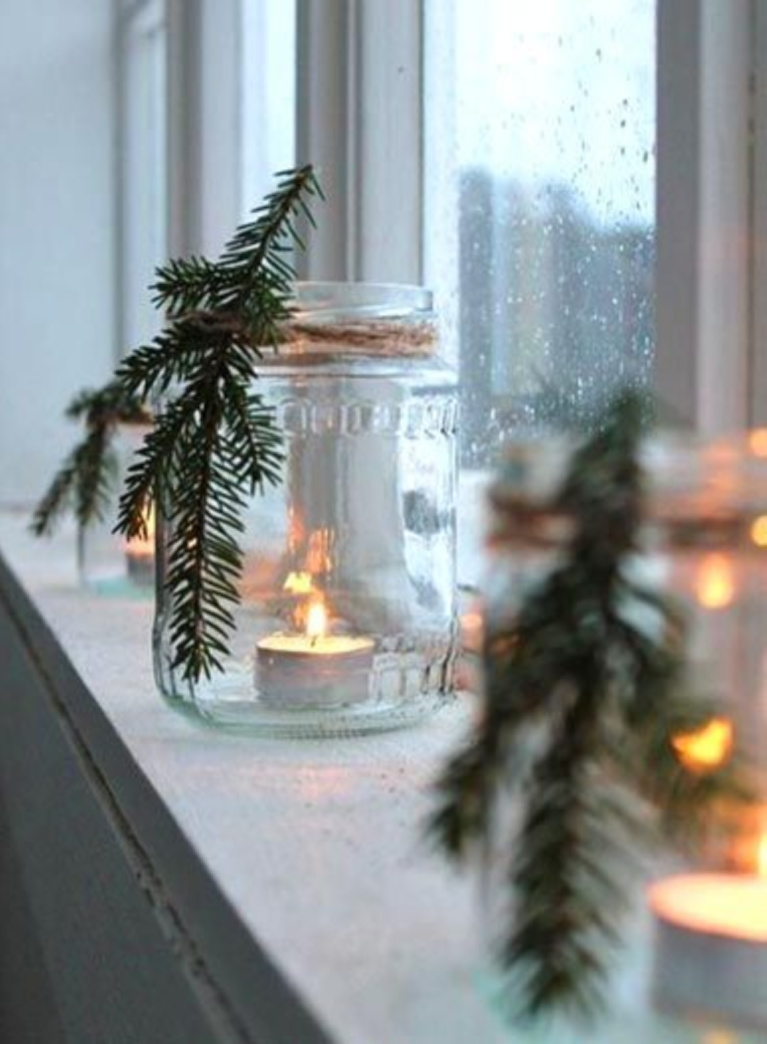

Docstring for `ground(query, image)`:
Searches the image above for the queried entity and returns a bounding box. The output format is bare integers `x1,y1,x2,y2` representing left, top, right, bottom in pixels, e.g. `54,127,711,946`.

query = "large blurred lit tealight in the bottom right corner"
649,837,767,1029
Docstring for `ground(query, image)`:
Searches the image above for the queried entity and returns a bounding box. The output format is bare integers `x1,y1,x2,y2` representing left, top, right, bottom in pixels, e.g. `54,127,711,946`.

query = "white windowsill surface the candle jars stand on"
0,514,745,1044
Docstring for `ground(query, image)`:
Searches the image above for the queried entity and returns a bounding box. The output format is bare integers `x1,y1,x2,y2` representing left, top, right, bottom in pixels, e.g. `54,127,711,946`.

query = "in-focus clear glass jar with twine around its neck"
154,283,457,736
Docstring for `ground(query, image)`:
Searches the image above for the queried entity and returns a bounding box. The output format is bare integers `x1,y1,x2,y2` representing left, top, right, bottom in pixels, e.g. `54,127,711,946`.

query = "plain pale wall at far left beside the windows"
0,0,116,504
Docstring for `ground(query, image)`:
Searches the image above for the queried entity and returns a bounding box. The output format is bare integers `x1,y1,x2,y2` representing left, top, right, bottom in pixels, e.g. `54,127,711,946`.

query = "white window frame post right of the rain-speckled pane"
655,0,752,433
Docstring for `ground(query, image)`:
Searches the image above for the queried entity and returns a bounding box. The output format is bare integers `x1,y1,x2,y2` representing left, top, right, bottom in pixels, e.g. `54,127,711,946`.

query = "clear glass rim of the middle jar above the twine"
290,281,434,324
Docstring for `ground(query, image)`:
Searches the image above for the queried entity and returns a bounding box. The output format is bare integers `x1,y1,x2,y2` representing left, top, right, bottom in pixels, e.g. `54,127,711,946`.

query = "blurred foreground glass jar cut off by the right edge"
482,431,767,1042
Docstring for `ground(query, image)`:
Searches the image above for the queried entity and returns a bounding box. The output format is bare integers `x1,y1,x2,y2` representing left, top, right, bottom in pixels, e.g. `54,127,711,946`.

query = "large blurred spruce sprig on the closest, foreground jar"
429,395,750,1018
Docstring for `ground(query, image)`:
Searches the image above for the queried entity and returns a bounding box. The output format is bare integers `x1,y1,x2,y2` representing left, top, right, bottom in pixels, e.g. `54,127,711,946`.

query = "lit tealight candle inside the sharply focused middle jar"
256,599,375,710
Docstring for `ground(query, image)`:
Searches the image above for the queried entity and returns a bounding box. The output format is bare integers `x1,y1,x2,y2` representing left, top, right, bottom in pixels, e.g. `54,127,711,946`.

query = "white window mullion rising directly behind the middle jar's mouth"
296,0,423,282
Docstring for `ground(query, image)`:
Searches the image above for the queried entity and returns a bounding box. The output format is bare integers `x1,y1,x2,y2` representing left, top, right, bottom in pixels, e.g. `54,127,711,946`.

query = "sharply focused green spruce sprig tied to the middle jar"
116,166,321,682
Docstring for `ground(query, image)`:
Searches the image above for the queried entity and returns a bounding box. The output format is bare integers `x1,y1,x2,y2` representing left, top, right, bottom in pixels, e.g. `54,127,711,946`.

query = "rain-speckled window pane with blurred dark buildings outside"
425,0,656,466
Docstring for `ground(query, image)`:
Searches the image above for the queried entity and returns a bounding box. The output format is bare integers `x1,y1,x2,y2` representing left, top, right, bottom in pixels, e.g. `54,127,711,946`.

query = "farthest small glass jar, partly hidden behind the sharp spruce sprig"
77,423,154,598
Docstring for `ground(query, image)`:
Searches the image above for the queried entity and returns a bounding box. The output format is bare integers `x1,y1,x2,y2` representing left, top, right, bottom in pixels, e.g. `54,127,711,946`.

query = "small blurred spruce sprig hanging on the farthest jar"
31,380,150,537
